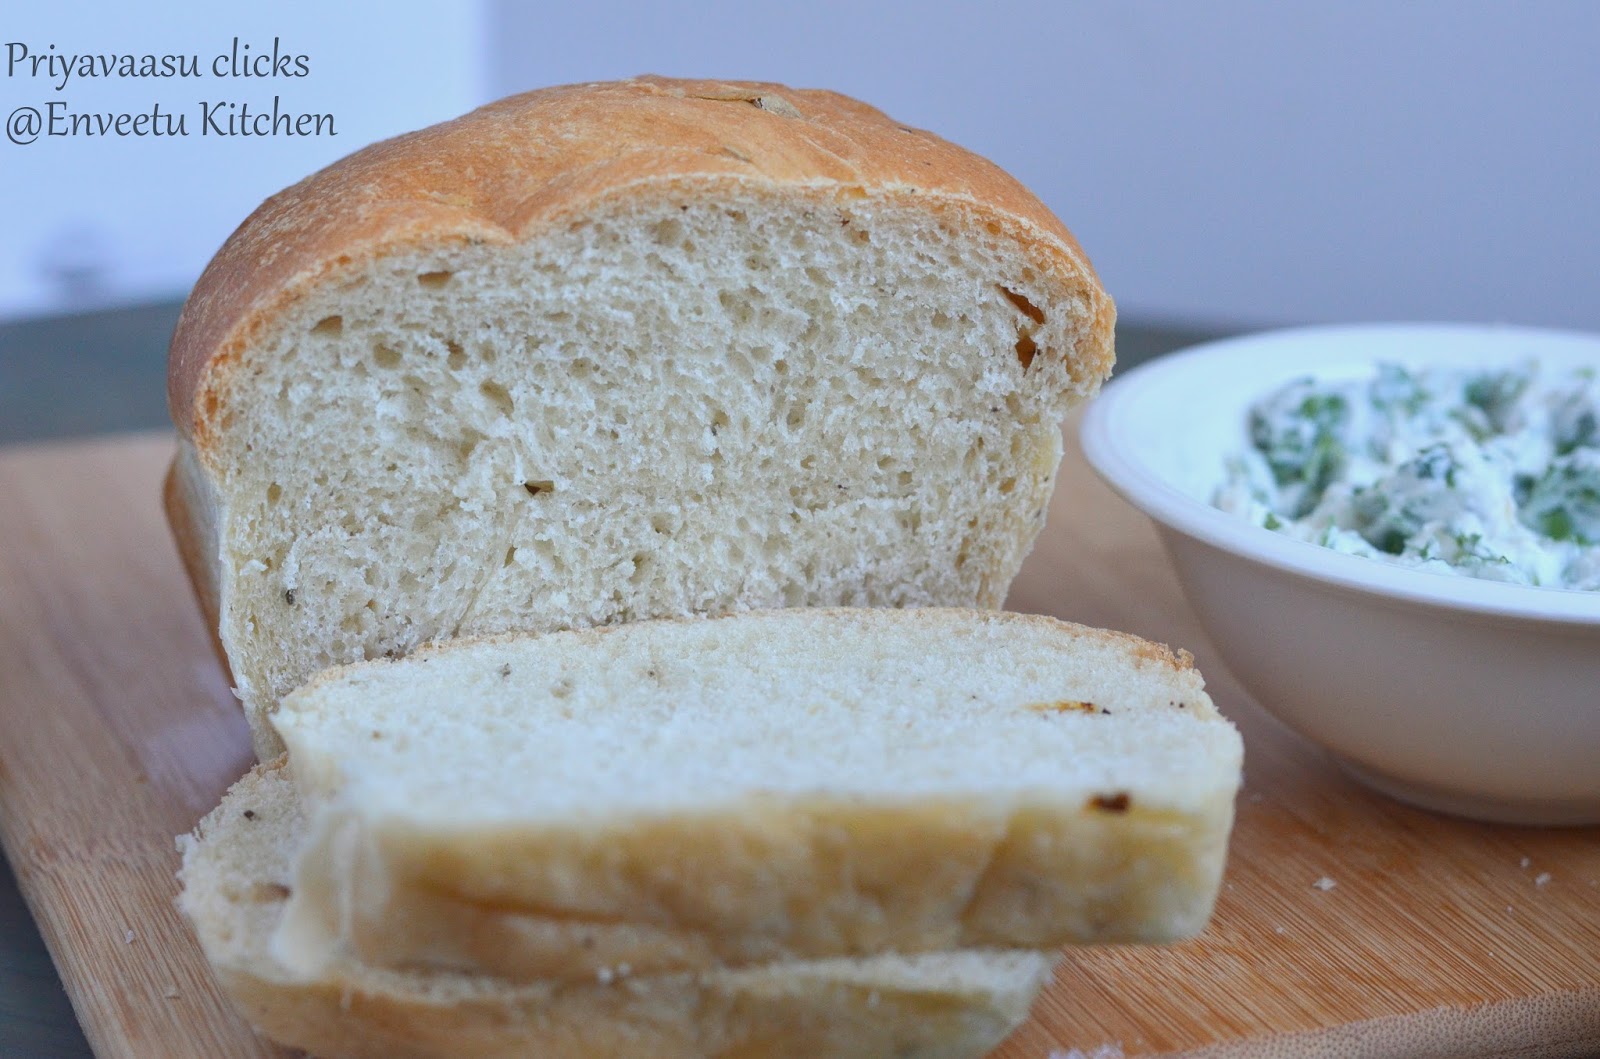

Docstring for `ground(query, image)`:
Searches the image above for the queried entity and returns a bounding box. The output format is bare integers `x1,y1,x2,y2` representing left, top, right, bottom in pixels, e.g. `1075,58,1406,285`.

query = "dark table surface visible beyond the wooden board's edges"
0,302,1229,1059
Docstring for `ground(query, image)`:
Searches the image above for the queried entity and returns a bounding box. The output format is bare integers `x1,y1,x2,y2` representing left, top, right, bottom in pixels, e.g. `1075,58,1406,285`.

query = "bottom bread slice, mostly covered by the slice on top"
179,765,1051,1059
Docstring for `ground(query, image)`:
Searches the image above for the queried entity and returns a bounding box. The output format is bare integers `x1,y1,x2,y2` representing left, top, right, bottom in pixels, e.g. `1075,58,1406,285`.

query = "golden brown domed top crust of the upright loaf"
168,77,1115,451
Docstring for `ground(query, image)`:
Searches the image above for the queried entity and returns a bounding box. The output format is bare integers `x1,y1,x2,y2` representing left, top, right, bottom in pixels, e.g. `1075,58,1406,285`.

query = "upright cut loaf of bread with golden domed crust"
166,77,1115,760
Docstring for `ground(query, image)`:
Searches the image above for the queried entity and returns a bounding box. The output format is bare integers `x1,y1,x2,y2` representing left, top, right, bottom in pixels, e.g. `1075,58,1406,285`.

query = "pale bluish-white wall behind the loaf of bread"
0,0,1600,330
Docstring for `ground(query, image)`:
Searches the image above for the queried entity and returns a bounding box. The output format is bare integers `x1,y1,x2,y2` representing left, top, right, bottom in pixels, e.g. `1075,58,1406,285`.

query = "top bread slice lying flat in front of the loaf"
275,609,1242,979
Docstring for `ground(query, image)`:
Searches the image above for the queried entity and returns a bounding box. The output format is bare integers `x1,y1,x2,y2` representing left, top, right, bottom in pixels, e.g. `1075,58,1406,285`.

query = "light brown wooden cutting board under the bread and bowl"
0,435,1600,1059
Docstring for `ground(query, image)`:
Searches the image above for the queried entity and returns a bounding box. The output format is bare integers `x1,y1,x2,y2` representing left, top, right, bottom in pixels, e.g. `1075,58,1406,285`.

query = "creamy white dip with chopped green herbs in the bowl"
1218,363,1600,590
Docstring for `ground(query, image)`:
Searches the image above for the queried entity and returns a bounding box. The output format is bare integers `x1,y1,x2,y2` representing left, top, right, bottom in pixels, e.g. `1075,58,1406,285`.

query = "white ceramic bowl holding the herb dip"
1082,325,1600,824
